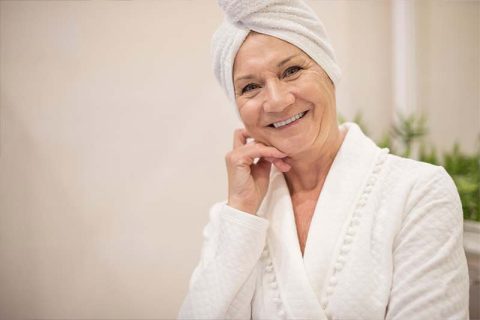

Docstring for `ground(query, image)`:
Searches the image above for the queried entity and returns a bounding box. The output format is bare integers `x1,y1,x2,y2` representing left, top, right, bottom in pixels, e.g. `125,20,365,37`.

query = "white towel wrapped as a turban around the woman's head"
212,0,341,102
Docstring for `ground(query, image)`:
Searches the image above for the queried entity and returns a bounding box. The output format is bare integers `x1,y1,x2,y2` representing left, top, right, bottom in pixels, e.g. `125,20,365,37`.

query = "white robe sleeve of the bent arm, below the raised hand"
178,203,269,319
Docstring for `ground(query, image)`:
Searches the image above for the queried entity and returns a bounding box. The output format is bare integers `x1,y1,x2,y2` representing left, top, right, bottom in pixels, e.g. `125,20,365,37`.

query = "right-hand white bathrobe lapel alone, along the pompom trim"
304,123,382,305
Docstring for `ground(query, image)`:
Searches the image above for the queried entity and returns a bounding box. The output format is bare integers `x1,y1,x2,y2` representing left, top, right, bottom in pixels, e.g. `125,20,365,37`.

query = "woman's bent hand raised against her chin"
225,129,290,214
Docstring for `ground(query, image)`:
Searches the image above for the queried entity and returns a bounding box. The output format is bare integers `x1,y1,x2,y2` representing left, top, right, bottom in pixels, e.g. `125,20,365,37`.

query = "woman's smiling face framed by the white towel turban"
233,33,337,156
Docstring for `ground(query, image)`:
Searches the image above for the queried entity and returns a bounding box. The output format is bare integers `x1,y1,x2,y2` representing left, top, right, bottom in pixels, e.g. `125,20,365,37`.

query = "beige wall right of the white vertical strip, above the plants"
416,0,480,151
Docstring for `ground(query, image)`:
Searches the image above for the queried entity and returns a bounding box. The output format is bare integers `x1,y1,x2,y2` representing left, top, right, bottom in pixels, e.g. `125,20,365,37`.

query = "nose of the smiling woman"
263,79,295,112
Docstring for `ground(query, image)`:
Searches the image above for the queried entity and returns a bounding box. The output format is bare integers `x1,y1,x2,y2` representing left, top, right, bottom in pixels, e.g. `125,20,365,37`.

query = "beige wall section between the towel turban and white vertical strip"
309,0,392,138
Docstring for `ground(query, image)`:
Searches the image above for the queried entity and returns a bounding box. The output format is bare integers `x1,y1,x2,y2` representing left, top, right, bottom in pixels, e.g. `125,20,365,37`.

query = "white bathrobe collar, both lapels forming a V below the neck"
259,123,381,319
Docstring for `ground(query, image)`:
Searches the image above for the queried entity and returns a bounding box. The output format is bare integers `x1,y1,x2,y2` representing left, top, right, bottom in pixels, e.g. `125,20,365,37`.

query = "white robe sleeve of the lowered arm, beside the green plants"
386,167,469,319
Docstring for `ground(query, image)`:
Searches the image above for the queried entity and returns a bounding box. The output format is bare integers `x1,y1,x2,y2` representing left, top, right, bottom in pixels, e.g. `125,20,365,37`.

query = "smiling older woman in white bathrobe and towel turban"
179,0,468,320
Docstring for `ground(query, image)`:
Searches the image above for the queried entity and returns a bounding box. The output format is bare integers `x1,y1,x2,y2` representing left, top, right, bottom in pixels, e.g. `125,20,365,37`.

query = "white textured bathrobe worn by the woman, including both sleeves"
179,123,469,320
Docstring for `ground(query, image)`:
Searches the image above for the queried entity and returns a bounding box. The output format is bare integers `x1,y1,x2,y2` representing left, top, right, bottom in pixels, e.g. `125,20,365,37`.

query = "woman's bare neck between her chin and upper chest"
285,127,346,195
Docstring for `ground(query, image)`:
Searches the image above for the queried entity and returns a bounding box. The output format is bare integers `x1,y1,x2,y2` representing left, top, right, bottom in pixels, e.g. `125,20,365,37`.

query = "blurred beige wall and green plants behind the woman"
0,0,480,319
